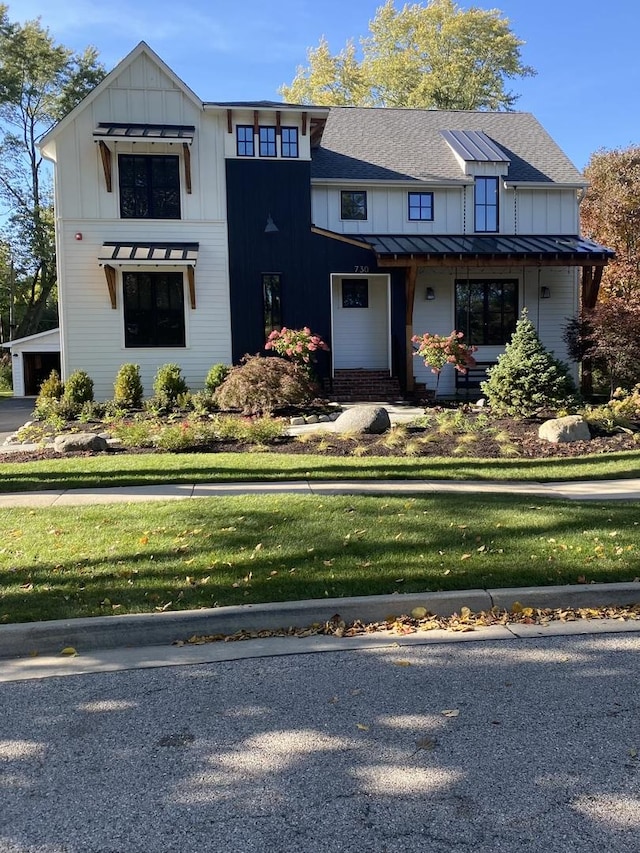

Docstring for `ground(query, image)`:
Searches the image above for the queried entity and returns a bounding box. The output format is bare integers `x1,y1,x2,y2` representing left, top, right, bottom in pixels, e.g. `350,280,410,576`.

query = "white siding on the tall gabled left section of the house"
47,53,231,399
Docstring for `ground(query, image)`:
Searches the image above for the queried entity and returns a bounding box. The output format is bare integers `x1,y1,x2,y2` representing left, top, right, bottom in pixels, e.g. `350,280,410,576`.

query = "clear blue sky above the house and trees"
13,0,640,169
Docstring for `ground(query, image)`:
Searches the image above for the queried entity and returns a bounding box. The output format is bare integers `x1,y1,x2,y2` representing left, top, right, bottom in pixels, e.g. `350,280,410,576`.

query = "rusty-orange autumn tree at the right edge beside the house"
580,145,640,305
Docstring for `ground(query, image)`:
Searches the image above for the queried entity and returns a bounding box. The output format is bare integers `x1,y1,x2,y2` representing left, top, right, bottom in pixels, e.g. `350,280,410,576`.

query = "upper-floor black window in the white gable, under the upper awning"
118,154,180,219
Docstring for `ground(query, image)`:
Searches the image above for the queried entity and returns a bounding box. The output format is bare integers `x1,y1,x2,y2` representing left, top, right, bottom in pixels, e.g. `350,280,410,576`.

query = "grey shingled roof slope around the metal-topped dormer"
311,107,586,184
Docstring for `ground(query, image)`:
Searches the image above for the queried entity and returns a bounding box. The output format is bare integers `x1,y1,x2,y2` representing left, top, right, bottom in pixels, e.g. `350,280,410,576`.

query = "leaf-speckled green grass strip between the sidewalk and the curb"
0,490,640,623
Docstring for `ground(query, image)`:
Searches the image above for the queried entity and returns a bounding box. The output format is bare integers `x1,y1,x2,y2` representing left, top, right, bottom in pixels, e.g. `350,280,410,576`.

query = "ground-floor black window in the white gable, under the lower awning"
123,272,185,347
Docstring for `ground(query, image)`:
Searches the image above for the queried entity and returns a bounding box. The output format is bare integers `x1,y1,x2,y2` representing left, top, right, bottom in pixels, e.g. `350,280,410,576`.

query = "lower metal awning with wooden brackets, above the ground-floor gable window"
98,242,200,308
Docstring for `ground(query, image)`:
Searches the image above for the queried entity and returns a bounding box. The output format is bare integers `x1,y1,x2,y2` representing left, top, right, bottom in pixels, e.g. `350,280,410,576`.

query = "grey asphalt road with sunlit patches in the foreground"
0,633,640,853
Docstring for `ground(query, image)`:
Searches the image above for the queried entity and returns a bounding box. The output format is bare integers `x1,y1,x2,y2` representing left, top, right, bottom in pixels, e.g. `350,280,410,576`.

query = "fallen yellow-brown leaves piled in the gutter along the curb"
174,601,640,644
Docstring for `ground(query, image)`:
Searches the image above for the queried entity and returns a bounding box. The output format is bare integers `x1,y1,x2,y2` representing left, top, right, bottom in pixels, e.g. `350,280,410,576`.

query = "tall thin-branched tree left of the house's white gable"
0,4,106,337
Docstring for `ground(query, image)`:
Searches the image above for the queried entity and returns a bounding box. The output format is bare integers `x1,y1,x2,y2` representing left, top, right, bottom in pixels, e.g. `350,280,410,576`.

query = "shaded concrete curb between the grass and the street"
0,583,640,659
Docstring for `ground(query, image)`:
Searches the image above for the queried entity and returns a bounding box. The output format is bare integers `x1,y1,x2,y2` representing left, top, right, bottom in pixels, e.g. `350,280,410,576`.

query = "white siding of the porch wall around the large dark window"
413,267,578,395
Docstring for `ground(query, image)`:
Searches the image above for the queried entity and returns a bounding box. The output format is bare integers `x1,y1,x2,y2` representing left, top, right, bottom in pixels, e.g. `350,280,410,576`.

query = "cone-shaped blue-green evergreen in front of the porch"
480,308,576,418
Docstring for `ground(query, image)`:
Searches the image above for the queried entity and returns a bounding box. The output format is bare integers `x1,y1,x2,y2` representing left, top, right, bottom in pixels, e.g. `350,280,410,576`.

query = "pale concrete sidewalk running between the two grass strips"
0,478,640,508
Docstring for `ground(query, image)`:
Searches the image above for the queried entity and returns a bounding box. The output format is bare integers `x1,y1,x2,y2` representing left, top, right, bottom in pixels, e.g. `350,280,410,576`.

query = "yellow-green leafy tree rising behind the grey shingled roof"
280,0,535,110
